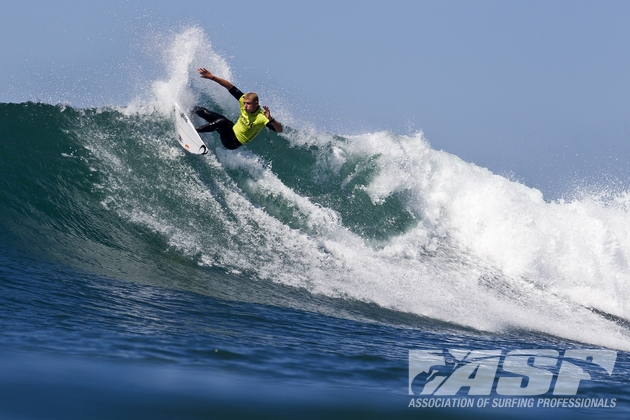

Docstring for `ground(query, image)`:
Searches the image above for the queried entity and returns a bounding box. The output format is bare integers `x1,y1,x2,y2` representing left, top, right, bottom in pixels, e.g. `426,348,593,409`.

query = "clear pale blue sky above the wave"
0,0,630,198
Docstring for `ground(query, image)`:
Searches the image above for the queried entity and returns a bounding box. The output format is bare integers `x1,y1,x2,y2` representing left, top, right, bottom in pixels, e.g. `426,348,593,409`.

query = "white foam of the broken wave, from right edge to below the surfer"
201,133,630,349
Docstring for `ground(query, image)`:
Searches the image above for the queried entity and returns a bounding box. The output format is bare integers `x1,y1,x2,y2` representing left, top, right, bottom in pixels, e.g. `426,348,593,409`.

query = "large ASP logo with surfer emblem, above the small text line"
409,349,617,396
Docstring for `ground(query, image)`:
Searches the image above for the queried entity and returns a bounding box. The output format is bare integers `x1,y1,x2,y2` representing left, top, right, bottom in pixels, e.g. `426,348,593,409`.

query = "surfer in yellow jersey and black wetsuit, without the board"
193,68,282,150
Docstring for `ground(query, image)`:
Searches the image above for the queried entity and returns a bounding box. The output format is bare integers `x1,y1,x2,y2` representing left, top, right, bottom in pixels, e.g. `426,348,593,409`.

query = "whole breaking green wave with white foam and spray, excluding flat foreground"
0,28,630,350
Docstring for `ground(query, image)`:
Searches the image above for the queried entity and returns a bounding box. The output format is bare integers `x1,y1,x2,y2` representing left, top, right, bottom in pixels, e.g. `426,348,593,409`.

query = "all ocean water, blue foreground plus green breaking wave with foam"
0,28,630,419
